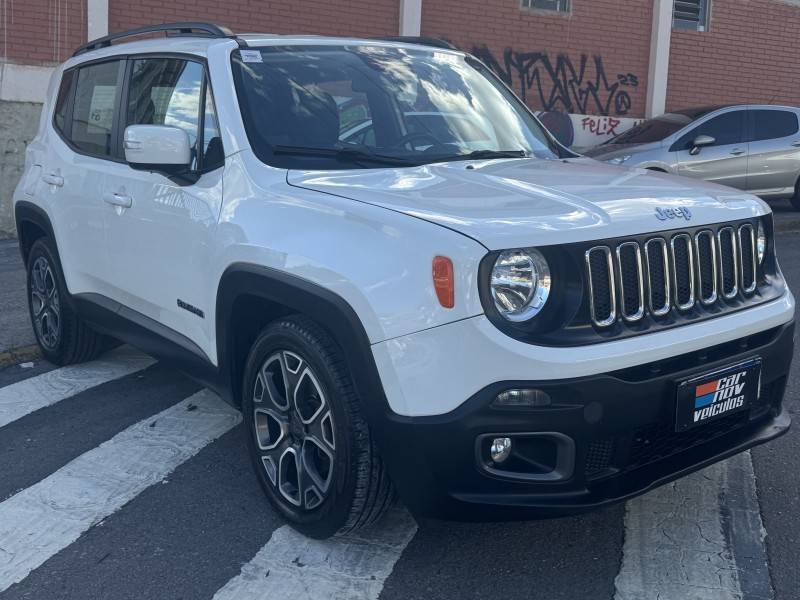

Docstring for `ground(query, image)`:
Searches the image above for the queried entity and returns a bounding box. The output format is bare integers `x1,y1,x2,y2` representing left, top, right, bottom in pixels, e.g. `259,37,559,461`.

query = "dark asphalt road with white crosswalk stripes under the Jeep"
0,223,800,600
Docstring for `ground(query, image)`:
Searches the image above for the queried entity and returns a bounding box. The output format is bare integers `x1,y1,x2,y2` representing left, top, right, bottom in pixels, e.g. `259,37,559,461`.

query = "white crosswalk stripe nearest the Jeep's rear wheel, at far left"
0,347,155,427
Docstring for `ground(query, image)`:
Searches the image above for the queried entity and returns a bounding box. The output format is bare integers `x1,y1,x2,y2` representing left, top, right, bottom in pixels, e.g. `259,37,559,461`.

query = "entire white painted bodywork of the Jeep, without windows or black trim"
14,36,794,416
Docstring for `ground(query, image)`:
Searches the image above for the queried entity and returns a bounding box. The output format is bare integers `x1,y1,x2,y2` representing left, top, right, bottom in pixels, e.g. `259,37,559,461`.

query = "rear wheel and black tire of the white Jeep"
27,237,109,366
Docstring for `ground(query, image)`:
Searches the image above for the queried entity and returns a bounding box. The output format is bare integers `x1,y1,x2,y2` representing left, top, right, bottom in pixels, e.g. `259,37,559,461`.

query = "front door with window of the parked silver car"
670,109,747,189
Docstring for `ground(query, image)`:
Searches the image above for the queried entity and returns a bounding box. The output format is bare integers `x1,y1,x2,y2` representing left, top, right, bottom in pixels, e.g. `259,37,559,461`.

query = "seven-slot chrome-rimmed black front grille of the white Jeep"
585,223,758,328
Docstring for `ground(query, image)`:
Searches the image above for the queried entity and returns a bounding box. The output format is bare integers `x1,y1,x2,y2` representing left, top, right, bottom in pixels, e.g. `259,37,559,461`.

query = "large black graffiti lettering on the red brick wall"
472,46,639,116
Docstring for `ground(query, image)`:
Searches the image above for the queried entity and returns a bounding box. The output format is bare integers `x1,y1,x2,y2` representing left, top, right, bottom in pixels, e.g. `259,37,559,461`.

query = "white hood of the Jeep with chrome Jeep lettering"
287,158,769,250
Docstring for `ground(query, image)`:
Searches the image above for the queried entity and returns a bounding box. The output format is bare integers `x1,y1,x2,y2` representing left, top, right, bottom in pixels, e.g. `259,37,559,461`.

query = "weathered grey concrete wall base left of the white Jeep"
0,100,42,238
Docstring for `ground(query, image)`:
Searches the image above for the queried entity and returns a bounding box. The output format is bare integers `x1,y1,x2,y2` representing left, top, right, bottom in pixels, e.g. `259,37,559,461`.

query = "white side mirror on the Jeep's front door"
123,125,192,174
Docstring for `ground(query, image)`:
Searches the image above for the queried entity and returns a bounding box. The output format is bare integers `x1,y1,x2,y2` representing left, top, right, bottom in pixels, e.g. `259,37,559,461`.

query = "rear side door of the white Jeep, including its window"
39,60,123,294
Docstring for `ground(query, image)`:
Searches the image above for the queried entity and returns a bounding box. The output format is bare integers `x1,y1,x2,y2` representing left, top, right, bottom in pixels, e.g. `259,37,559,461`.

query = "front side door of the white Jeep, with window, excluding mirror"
104,57,224,355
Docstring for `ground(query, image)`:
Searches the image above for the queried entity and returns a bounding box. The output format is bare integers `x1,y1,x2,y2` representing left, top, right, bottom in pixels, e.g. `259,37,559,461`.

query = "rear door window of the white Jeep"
70,60,121,158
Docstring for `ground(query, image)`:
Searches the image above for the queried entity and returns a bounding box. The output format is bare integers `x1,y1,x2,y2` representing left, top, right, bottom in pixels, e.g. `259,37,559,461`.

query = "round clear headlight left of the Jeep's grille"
490,250,550,323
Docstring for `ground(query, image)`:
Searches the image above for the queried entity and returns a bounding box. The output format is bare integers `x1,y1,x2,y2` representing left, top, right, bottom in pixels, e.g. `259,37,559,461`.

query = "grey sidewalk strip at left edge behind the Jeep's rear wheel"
0,240,38,360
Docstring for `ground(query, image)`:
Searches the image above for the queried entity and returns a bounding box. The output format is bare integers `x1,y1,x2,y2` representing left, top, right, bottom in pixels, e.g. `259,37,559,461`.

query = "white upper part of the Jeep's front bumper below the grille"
372,292,794,416
